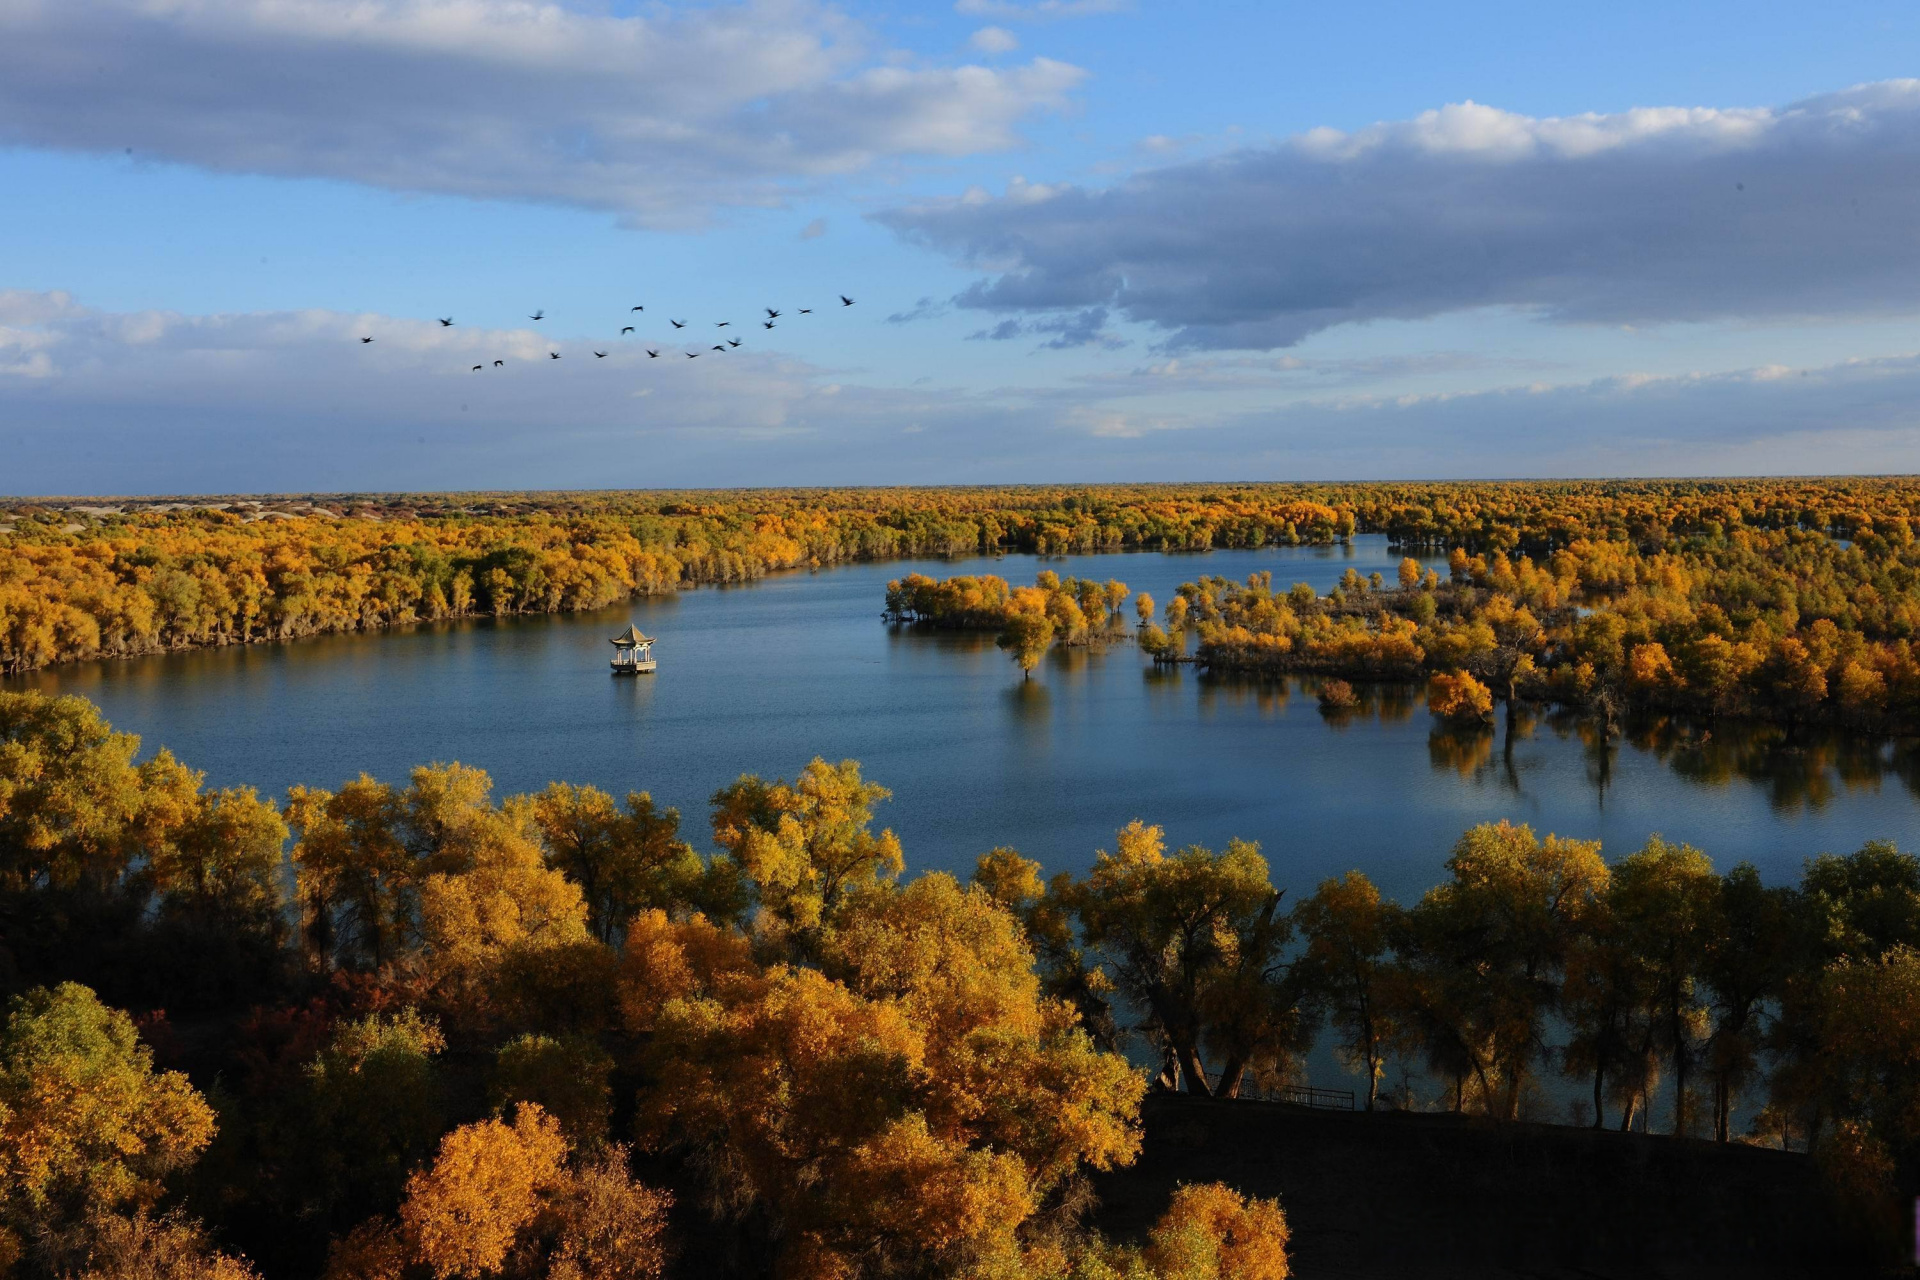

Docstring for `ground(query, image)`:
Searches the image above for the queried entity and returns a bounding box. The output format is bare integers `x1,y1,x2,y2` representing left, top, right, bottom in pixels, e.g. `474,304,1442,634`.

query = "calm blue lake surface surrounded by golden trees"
4,537,1920,898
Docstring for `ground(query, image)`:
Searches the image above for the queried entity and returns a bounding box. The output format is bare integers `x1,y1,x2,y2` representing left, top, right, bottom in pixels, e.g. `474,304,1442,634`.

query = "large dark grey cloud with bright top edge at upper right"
879,81,1920,351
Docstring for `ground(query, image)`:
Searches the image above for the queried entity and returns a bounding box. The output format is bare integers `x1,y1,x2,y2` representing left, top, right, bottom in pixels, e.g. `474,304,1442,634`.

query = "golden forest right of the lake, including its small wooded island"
867,482,1920,733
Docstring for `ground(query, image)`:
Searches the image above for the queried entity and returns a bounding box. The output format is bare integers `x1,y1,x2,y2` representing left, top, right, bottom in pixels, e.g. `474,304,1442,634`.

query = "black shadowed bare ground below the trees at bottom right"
1094,1094,1885,1280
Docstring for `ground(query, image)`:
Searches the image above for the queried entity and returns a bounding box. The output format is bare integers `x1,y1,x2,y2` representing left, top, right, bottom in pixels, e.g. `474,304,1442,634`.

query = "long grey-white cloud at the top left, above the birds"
0,0,1083,225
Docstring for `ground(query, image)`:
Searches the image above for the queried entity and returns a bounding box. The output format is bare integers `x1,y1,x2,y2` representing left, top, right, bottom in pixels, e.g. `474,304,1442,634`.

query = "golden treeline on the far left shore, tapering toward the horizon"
0,486,1354,672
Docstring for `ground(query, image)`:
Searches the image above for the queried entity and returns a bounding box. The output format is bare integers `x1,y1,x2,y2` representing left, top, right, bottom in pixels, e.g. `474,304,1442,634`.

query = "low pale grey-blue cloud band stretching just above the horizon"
11,292,1920,493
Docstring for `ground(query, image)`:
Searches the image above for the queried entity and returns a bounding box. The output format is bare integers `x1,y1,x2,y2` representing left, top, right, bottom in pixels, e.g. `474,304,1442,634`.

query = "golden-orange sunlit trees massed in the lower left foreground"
0,695,1284,1280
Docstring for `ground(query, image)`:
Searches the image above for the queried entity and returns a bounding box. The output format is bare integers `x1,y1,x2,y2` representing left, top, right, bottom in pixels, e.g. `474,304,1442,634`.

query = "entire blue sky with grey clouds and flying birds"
0,0,1920,495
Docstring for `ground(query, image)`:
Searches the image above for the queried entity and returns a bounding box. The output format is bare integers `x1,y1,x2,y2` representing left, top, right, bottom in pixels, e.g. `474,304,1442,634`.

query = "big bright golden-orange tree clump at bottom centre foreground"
622,877,1140,1276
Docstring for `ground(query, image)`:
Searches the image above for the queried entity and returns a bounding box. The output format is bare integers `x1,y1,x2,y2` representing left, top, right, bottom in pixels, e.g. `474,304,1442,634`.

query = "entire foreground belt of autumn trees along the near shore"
0,694,1920,1280
